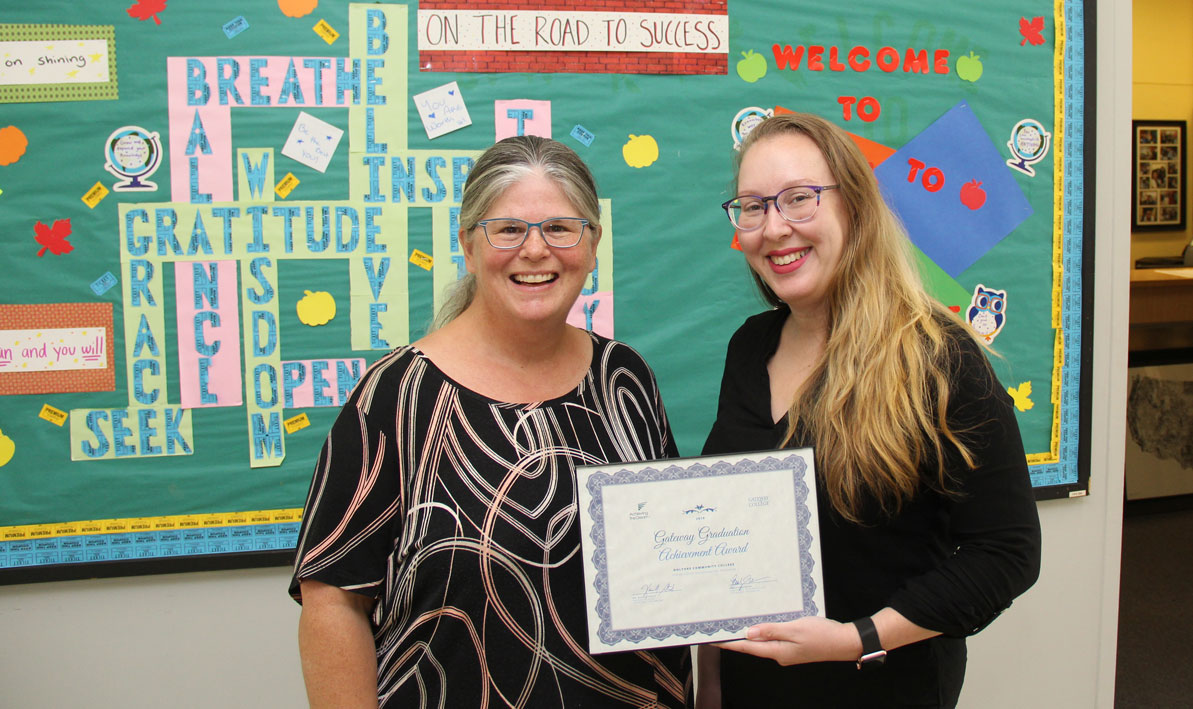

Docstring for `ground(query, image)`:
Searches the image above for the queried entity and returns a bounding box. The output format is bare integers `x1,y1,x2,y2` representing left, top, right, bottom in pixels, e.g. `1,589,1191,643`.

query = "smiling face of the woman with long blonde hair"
737,132,847,312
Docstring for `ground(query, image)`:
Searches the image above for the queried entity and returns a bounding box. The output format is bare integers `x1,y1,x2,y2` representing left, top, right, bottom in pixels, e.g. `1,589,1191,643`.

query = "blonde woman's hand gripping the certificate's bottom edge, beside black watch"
716,616,861,665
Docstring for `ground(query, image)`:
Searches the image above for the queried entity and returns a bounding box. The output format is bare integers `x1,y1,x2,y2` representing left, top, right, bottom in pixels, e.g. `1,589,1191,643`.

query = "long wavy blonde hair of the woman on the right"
737,113,975,522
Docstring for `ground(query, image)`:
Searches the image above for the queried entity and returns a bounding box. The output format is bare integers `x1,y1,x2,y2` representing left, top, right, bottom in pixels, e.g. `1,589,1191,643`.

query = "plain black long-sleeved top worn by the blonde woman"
704,308,1040,707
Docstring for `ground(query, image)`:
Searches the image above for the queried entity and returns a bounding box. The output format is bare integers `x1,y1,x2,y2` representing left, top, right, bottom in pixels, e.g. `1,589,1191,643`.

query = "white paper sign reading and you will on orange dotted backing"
0,327,107,372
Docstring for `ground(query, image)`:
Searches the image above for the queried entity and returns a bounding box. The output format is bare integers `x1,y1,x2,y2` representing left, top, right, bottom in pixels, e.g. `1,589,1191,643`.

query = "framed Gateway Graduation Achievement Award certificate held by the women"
576,449,824,653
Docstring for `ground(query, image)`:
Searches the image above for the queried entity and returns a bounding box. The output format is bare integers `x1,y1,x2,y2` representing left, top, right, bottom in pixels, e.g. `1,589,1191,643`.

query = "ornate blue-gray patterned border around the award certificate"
586,451,820,646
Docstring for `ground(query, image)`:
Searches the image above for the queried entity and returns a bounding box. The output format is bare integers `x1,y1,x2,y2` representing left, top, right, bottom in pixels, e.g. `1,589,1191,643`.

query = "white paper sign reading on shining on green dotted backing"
0,39,109,86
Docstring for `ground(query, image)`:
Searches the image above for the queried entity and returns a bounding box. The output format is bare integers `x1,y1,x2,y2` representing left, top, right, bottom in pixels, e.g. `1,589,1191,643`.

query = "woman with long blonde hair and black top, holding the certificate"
698,113,1040,708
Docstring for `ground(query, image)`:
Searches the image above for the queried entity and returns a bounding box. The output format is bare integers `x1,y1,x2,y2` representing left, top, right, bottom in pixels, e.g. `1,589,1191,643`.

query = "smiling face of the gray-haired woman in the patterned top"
459,172,600,326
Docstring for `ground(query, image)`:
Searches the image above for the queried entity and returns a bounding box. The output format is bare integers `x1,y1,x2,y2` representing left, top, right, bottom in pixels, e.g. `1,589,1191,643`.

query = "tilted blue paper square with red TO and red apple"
874,101,1032,278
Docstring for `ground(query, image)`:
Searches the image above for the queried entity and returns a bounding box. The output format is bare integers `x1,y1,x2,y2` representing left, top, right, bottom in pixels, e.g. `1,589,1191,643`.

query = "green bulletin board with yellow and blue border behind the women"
0,0,1093,582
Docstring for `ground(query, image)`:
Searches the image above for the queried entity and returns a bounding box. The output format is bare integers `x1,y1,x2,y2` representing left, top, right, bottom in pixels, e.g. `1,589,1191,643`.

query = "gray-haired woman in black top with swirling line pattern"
290,136,691,708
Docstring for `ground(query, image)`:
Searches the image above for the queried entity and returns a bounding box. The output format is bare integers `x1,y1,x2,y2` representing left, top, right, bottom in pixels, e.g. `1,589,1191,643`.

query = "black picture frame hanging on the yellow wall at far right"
1131,121,1186,232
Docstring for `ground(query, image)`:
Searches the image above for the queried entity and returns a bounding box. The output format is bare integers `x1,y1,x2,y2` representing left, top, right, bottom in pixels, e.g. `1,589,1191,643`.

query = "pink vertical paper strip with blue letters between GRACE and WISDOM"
174,261,245,408
